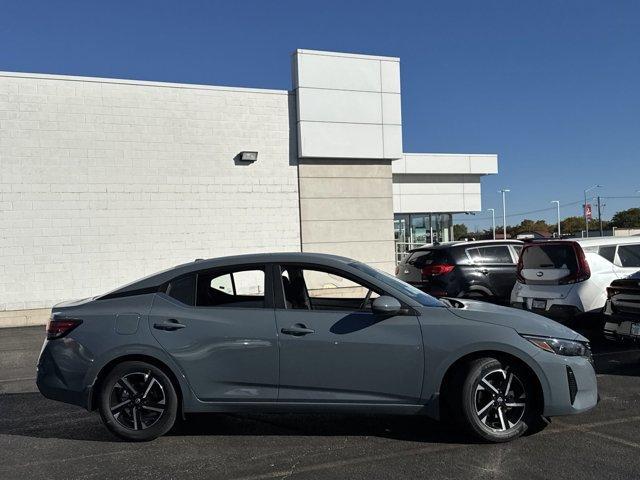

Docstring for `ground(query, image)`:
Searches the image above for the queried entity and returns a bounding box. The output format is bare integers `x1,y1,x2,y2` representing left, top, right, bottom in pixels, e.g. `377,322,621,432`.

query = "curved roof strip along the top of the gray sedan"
100,252,357,298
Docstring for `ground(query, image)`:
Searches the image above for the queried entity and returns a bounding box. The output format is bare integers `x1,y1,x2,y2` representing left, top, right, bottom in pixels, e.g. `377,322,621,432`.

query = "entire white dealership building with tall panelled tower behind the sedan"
0,50,497,326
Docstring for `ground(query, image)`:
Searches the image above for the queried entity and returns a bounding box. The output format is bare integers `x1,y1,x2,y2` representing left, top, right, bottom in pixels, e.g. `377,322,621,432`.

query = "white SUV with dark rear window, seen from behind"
511,237,640,318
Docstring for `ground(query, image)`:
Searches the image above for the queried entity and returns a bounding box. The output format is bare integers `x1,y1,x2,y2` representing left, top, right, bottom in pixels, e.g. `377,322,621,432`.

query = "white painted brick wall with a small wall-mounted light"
0,74,300,310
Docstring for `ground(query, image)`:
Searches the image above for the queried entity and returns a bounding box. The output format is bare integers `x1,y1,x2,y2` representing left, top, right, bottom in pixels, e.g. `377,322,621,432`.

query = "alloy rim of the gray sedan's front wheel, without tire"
474,368,527,433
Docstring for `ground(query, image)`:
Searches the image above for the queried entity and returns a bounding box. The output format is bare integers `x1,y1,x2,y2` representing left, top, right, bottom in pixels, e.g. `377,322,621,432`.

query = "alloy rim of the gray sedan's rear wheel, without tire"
109,371,166,430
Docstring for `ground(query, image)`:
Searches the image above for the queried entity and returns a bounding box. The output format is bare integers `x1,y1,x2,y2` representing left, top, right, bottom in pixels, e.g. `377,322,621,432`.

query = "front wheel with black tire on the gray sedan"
458,358,543,443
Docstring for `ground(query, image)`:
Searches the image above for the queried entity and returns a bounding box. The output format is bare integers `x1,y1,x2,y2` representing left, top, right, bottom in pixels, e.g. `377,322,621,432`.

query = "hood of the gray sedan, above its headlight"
443,298,587,342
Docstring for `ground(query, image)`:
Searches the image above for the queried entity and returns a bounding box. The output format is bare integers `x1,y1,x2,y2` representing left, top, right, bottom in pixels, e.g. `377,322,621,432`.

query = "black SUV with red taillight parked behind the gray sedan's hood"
396,240,523,304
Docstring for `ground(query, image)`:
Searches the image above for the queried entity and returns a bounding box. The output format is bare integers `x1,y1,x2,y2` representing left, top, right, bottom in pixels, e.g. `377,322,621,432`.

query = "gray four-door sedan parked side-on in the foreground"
37,253,598,442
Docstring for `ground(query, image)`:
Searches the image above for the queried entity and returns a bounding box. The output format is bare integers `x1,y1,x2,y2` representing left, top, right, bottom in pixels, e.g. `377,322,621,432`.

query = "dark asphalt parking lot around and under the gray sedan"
0,327,640,480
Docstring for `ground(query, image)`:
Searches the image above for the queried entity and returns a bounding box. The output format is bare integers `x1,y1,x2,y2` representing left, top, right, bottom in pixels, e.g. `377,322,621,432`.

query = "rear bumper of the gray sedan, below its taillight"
36,338,89,408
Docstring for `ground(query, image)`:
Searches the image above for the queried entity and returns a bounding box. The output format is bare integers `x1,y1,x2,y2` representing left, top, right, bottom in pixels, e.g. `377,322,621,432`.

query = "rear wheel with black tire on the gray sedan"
98,361,178,442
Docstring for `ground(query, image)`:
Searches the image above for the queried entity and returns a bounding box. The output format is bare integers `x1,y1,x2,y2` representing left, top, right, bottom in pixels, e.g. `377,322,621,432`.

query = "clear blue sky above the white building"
0,0,640,231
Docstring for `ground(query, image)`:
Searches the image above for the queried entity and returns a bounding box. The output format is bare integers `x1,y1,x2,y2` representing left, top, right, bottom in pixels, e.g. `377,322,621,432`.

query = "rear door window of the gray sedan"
196,268,265,308
